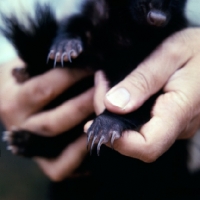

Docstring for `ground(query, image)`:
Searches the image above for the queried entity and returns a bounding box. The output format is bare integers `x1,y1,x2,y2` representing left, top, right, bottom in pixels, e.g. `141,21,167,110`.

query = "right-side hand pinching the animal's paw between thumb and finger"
85,28,200,162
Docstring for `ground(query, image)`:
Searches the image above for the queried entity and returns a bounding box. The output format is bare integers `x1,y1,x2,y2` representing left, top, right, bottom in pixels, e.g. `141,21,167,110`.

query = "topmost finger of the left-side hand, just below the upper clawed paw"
0,69,91,127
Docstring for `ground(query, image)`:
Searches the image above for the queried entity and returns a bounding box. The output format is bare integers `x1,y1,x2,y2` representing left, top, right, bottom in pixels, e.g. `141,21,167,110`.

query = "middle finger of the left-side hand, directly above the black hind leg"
20,88,94,136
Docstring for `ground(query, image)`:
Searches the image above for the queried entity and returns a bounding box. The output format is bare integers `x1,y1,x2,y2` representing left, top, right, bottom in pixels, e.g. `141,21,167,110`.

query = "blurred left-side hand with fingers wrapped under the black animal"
0,59,93,180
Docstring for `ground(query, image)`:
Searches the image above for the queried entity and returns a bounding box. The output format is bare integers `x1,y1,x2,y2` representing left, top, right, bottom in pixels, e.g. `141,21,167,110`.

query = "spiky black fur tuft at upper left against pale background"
3,5,58,75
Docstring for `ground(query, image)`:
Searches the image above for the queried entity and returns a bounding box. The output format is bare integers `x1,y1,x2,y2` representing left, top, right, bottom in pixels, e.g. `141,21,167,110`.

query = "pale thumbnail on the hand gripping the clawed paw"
106,88,130,109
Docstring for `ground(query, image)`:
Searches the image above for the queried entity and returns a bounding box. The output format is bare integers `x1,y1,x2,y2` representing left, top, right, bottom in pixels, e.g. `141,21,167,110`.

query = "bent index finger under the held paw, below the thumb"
109,94,187,163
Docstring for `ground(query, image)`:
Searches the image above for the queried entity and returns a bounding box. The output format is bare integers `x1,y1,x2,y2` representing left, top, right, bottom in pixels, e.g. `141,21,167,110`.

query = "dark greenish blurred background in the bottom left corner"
0,124,49,200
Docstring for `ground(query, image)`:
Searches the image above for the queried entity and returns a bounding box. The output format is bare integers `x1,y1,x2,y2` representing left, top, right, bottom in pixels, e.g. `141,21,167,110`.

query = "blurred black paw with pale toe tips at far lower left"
2,130,31,156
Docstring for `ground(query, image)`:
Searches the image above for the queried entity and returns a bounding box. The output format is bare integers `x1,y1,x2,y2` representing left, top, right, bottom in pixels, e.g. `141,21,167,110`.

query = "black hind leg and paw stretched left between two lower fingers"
2,125,83,158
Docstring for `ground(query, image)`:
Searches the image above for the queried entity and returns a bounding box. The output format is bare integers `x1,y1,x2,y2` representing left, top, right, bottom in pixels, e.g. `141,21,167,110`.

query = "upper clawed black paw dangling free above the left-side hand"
47,37,83,67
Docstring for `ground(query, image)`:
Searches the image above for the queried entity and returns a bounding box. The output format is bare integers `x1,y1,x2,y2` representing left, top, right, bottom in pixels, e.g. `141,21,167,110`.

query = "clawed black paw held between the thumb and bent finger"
87,113,130,155
